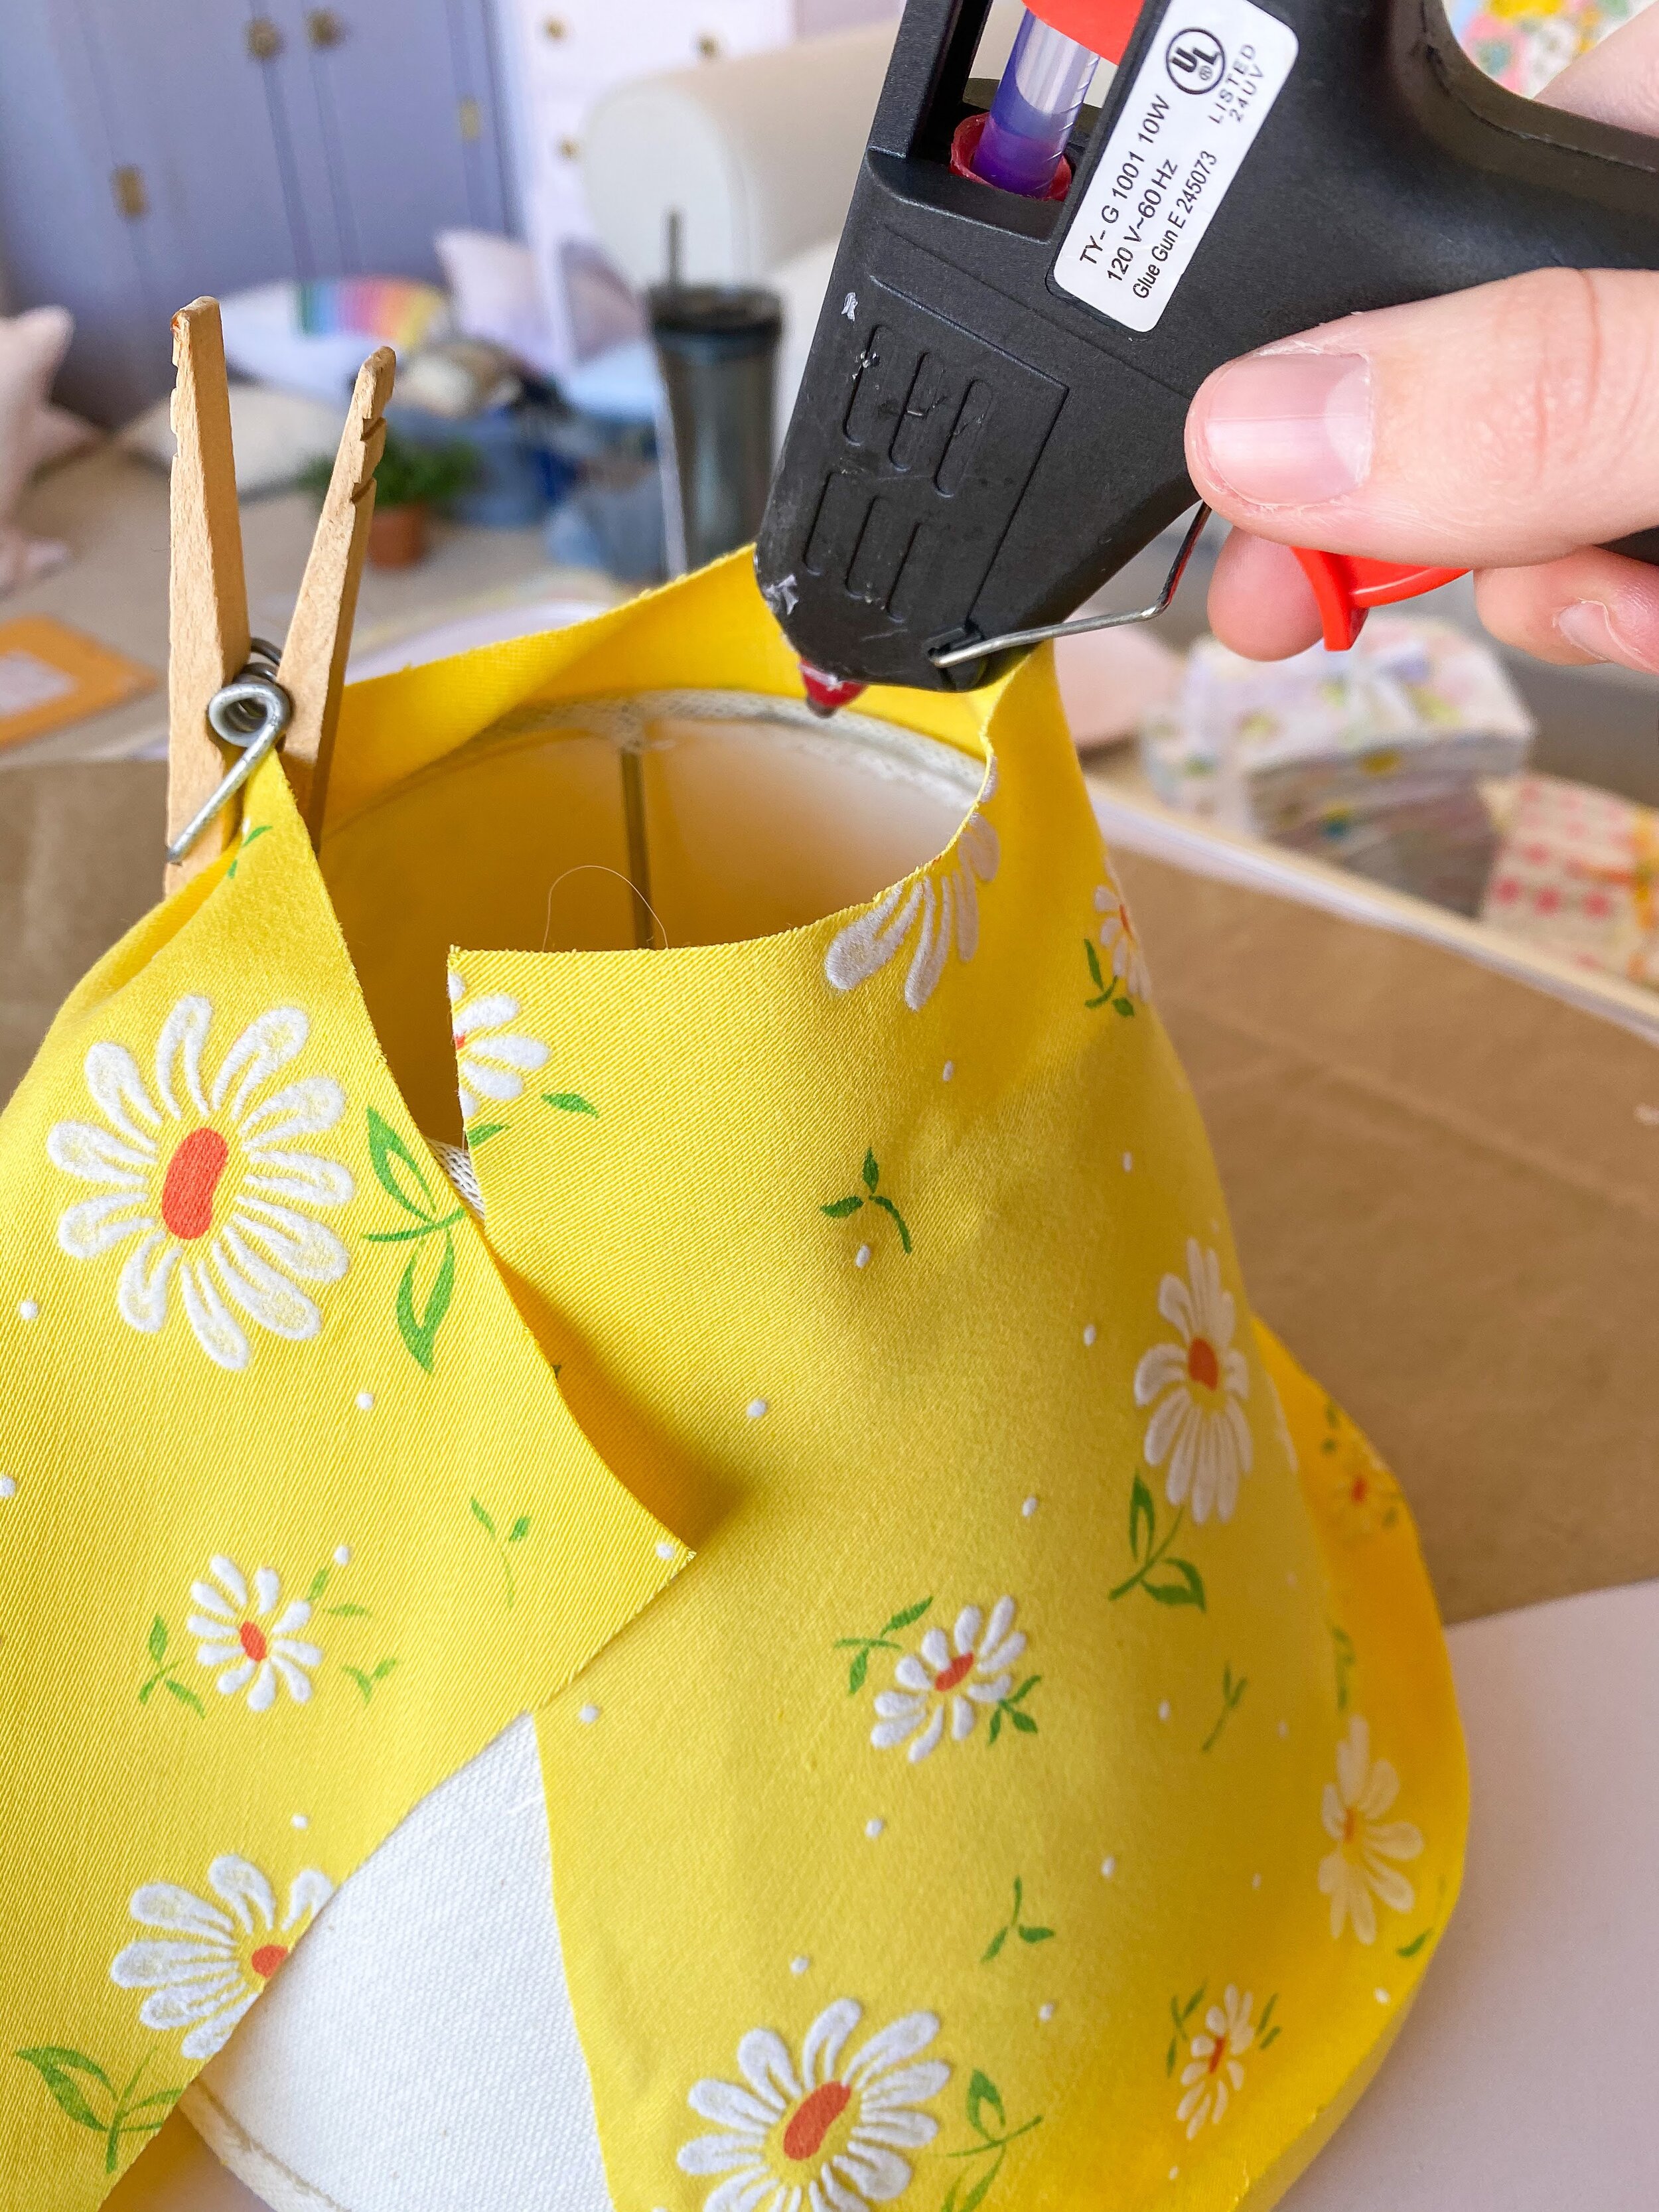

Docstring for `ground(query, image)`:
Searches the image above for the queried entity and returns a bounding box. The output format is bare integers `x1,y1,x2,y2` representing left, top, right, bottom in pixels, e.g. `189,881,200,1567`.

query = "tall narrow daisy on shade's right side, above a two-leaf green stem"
1135,1236,1254,1522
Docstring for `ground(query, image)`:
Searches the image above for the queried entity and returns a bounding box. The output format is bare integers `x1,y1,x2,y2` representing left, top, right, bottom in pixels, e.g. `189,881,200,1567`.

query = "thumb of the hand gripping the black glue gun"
1188,267,1659,569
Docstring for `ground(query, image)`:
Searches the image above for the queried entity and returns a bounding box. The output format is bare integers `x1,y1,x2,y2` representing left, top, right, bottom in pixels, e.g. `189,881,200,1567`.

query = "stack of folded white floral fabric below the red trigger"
1141,615,1535,914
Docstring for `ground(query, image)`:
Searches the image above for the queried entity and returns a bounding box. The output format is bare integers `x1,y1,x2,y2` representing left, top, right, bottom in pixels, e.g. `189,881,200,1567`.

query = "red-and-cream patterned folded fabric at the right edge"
1480,776,1659,989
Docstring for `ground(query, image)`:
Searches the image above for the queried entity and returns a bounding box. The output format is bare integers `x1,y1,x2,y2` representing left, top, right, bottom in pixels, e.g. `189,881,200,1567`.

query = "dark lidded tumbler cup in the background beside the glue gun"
648,283,783,569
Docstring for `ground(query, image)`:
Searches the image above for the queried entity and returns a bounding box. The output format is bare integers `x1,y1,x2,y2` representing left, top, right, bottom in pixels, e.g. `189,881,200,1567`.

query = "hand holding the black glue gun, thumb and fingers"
1186,5,1659,672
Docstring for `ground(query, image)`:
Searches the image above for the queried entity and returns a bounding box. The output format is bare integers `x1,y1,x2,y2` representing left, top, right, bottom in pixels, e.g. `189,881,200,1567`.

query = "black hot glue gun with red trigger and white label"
755,0,1659,708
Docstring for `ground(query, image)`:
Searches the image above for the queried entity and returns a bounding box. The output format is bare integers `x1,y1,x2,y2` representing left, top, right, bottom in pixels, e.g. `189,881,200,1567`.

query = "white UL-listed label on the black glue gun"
1055,0,1296,330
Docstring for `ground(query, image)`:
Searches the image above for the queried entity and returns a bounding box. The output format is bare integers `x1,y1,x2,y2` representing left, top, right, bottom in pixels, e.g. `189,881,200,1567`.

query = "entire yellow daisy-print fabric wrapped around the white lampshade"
0,540,1467,2212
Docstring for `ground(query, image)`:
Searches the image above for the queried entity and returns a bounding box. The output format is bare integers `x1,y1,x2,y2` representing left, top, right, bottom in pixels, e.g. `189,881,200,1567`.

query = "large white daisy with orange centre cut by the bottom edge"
679,1998,951,2212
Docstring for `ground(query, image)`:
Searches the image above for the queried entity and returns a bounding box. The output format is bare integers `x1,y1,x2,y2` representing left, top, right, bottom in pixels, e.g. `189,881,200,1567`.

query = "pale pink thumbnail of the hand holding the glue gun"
1199,354,1372,506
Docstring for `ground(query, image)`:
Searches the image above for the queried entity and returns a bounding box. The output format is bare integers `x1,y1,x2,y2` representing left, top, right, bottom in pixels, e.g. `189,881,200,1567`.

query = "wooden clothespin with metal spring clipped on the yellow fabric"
166,299,396,891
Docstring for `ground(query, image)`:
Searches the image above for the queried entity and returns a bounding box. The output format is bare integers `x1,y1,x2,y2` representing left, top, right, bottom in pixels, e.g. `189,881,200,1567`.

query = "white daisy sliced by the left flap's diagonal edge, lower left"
108,1856,334,2059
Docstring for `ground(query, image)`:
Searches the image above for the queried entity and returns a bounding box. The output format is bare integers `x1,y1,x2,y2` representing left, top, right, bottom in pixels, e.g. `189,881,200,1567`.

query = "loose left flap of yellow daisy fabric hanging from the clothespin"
0,772,685,2212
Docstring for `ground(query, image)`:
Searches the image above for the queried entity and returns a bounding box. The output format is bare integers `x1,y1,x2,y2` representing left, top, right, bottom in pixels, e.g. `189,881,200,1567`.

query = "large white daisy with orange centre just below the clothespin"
46,997,354,1374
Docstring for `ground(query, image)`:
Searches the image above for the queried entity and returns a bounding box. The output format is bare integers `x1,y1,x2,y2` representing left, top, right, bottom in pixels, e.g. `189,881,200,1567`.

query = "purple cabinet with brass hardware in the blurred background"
0,0,511,423
